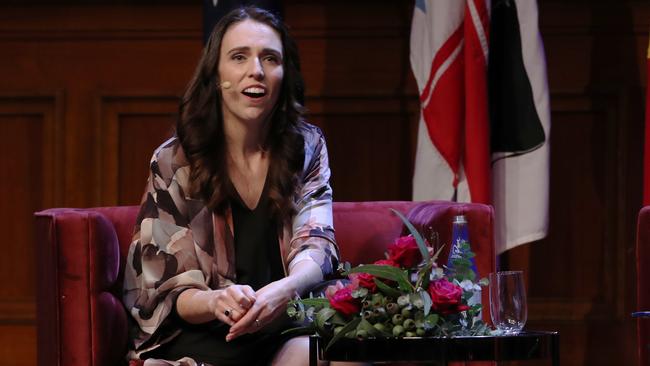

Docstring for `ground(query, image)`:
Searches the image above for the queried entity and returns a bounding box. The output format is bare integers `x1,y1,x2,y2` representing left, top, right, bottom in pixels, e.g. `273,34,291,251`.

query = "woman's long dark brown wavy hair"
176,7,304,224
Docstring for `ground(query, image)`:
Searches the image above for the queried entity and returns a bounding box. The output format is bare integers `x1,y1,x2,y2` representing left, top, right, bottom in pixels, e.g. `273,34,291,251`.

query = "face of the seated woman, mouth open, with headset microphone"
217,19,284,123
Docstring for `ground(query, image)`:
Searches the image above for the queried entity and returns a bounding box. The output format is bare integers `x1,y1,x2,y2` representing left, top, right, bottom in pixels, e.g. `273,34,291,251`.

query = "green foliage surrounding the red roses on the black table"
285,210,493,350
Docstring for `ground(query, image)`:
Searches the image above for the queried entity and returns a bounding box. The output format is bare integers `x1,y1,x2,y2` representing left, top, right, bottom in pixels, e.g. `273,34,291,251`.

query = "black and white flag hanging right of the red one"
488,0,551,251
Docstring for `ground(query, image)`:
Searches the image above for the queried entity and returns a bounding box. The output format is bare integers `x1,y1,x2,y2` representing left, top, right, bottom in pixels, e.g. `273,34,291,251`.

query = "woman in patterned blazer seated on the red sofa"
124,7,338,365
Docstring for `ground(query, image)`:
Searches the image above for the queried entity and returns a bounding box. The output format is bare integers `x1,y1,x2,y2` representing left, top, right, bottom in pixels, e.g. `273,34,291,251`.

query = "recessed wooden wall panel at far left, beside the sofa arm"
0,91,64,366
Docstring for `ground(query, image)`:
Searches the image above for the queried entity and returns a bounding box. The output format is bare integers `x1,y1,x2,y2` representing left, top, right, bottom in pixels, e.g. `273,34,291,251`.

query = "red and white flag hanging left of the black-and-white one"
411,0,490,203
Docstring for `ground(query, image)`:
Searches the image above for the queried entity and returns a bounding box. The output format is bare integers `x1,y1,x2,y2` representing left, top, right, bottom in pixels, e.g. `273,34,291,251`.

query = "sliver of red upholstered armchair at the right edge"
636,206,650,366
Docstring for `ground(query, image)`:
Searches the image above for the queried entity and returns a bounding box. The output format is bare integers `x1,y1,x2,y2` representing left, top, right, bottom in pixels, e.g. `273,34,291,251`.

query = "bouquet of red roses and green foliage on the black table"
287,210,491,348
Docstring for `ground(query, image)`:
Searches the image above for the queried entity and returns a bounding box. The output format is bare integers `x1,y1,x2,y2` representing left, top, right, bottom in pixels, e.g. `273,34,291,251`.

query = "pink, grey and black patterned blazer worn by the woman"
123,123,338,358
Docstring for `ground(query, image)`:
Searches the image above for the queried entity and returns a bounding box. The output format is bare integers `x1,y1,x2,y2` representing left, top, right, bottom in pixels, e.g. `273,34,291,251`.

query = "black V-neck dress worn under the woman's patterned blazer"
144,186,288,366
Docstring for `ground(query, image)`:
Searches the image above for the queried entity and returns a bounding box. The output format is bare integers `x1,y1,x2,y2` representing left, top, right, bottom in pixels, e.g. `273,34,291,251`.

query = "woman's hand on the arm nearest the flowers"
226,277,296,341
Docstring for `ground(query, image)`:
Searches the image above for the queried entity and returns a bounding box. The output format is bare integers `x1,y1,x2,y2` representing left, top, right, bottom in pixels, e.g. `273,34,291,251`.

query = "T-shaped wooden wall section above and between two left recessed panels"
0,3,201,207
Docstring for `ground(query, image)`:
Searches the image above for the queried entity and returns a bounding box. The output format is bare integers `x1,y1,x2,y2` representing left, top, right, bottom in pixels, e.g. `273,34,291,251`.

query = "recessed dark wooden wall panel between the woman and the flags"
309,96,419,201
